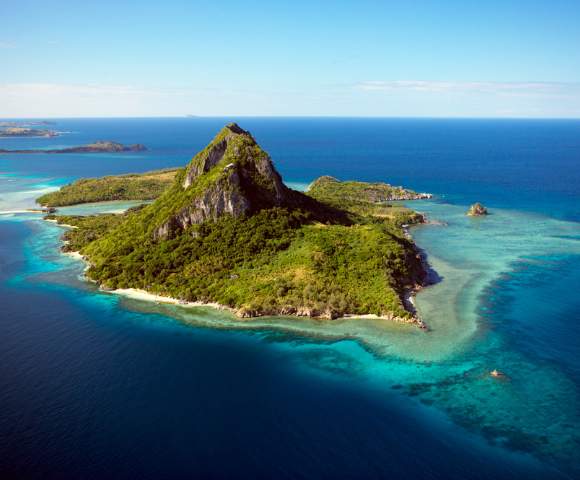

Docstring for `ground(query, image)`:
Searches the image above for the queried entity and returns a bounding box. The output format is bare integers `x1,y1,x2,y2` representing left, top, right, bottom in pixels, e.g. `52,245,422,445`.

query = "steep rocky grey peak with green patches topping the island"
153,123,322,240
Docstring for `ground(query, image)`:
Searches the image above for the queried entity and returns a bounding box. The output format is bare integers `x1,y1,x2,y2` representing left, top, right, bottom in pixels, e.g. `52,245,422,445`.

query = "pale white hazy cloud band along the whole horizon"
0,80,580,118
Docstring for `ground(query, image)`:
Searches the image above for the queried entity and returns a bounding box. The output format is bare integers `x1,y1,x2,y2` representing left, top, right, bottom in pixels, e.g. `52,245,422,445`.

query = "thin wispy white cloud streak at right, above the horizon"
355,80,580,95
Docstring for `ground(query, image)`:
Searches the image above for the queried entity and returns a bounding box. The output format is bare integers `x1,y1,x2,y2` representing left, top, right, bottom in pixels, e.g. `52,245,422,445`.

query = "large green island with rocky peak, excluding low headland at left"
41,124,427,328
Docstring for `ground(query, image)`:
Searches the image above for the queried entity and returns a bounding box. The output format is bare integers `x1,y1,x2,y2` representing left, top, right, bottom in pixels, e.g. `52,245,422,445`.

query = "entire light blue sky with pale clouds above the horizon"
0,0,580,118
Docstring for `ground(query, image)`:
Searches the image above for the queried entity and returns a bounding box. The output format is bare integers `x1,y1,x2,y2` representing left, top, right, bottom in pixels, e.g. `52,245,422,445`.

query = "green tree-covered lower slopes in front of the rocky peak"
59,209,421,317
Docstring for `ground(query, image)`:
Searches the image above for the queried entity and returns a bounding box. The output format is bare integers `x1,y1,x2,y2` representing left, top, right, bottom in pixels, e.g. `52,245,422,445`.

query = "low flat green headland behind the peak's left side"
36,169,178,207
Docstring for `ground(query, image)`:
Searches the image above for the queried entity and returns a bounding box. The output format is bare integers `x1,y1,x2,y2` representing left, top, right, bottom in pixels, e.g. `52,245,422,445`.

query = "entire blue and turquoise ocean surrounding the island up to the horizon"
0,118,580,479
